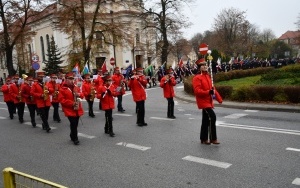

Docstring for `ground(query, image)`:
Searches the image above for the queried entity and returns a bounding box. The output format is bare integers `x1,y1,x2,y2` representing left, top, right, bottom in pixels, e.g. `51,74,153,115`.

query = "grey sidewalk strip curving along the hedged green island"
175,89,300,113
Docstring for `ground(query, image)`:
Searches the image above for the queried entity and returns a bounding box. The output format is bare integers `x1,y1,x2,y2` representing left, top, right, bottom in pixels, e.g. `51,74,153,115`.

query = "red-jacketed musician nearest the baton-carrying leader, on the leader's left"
160,68,176,119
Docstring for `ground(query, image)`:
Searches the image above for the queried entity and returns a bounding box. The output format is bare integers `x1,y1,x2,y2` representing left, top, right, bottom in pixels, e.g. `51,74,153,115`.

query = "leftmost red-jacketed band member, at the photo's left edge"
1,77,15,119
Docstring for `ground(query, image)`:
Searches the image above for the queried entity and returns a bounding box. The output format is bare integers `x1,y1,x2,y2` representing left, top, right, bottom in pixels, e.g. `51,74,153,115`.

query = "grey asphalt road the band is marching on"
0,85,300,188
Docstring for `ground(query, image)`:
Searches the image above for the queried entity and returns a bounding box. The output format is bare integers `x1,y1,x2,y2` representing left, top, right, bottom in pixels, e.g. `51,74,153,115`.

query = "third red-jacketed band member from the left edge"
22,76,37,127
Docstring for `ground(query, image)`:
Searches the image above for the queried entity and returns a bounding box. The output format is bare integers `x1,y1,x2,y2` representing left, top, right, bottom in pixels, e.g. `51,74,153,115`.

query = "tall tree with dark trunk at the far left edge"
0,0,49,75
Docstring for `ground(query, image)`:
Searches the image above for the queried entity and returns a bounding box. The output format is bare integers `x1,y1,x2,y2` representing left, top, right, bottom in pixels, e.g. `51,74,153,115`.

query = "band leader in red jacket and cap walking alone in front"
193,58,222,144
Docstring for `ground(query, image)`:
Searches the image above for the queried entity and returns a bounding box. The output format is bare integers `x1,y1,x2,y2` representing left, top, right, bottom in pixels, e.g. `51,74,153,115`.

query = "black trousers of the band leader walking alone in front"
200,108,217,141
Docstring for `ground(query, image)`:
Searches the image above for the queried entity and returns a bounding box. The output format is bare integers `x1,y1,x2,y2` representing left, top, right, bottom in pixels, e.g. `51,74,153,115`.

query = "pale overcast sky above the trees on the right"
183,0,300,39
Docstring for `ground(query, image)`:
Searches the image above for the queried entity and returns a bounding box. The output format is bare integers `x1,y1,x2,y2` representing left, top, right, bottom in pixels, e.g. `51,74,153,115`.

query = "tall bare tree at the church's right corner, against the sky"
142,0,193,65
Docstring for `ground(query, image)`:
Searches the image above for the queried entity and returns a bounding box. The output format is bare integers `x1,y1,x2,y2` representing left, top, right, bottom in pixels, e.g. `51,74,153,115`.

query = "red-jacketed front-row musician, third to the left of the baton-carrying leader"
97,75,116,137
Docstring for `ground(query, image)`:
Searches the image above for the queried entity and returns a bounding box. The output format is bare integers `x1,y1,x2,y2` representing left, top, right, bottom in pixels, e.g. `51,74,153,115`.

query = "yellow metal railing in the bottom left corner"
3,167,67,188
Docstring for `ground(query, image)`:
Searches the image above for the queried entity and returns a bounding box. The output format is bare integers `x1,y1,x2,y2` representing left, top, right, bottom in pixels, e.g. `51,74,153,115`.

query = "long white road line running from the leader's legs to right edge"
216,121,300,135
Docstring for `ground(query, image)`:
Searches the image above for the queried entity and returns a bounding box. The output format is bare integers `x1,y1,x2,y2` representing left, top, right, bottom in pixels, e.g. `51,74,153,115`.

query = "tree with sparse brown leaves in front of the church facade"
55,0,132,69
